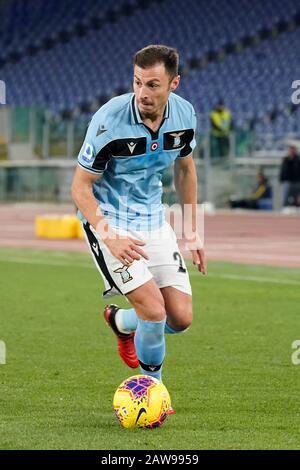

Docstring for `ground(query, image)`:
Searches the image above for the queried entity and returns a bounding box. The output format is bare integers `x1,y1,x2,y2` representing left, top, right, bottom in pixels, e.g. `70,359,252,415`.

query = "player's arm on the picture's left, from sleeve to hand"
71,116,148,265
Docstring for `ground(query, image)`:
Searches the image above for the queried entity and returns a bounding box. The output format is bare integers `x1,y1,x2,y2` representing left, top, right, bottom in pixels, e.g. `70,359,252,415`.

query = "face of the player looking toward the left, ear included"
133,64,180,117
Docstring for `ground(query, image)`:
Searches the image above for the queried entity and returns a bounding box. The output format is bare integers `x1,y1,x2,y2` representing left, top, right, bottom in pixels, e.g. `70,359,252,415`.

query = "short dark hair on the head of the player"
133,44,179,78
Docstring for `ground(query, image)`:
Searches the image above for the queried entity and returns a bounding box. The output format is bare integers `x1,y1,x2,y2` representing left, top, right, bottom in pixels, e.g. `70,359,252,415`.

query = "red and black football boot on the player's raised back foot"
104,304,140,369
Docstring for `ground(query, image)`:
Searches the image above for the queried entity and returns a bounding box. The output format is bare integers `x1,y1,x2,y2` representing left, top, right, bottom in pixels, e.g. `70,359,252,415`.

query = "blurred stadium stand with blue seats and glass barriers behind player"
0,0,300,207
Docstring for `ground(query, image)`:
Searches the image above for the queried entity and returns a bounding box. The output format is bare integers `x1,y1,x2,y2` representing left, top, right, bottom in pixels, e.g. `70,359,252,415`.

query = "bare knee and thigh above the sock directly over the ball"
126,279,166,321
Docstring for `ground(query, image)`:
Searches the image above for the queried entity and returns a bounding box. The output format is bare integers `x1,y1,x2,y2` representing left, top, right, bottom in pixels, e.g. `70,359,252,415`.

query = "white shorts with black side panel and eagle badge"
83,222,192,297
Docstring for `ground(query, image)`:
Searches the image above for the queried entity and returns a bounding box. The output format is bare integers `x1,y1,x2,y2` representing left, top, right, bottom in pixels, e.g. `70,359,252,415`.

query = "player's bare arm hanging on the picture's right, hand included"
174,154,207,274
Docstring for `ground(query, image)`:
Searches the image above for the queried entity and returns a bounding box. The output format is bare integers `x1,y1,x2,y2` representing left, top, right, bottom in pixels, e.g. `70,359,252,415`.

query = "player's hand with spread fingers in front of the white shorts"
103,232,149,266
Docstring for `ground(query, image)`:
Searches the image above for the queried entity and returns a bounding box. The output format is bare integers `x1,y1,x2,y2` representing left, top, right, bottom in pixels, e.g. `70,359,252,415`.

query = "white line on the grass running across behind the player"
0,256,300,286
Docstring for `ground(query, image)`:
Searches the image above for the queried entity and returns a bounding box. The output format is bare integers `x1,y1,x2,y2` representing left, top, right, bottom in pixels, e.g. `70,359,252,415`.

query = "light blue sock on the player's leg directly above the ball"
134,318,166,381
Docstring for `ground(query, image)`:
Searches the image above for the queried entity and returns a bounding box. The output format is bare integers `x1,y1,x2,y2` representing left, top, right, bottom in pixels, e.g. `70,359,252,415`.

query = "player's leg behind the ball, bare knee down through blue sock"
127,280,166,380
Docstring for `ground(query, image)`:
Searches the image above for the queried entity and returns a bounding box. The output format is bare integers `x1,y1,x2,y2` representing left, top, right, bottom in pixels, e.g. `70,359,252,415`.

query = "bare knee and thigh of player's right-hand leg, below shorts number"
160,287,193,330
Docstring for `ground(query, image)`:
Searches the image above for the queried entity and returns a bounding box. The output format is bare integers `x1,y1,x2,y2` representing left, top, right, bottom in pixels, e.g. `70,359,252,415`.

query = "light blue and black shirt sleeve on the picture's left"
78,116,111,174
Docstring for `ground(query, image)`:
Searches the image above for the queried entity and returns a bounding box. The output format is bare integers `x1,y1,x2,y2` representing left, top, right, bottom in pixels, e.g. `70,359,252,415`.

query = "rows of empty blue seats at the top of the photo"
0,0,300,135
